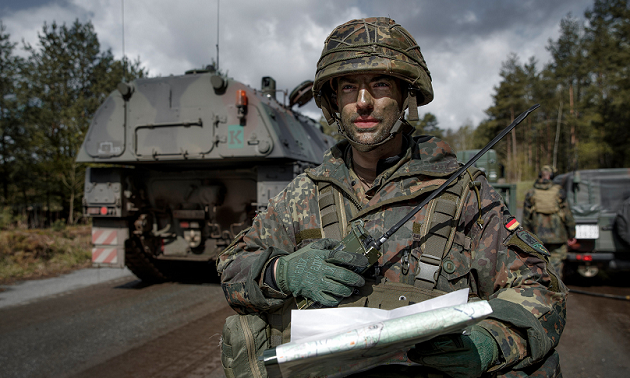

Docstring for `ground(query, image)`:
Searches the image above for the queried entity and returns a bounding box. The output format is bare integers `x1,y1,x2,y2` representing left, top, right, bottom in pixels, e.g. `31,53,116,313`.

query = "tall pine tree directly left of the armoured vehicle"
25,20,146,223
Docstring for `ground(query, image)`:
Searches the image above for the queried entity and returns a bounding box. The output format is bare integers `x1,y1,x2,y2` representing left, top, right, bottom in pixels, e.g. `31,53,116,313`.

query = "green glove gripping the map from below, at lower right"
407,325,499,378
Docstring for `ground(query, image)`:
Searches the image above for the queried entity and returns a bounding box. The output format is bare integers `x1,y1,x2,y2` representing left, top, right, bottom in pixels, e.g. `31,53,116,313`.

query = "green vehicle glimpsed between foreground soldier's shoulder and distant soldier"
457,149,517,215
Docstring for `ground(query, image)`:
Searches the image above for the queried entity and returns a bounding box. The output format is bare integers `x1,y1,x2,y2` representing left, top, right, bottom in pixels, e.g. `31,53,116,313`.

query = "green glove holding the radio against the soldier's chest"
276,239,368,307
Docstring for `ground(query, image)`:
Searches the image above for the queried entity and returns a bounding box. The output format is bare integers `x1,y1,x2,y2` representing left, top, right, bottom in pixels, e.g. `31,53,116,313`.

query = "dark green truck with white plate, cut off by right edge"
553,168,630,277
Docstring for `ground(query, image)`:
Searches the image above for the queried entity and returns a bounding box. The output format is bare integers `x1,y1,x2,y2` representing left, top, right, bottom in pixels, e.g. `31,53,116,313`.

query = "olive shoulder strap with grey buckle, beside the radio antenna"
414,168,483,289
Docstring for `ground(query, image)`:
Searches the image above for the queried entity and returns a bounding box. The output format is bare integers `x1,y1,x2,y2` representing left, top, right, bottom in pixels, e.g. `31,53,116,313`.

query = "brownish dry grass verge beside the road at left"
0,226,92,284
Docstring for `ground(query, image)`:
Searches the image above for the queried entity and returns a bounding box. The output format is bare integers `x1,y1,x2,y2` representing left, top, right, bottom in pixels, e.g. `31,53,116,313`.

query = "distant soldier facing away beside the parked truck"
523,165,575,279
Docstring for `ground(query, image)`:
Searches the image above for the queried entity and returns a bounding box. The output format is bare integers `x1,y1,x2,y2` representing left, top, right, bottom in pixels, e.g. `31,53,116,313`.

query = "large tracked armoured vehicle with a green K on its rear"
77,67,334,281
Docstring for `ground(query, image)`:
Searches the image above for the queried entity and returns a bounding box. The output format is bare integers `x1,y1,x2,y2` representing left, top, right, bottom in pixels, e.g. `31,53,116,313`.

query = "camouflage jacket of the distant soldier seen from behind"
523,179,575,244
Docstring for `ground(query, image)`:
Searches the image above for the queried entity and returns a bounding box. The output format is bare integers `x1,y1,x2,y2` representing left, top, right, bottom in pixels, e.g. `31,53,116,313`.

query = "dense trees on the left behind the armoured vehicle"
0,20,148,228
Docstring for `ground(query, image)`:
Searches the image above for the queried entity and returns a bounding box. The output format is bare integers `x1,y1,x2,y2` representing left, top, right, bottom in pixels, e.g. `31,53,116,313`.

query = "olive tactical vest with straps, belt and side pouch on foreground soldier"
221,168,483,378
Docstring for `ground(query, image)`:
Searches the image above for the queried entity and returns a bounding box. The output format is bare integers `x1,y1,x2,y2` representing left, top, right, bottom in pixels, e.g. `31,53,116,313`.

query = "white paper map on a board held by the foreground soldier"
267,289,492,378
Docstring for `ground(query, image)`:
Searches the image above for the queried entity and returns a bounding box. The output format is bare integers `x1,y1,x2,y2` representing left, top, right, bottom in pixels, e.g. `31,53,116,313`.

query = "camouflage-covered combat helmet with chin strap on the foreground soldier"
313,17,433,144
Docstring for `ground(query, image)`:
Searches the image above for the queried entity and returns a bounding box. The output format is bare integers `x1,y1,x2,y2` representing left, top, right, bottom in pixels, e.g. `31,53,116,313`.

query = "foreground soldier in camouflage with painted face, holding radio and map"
217,18,567,377
